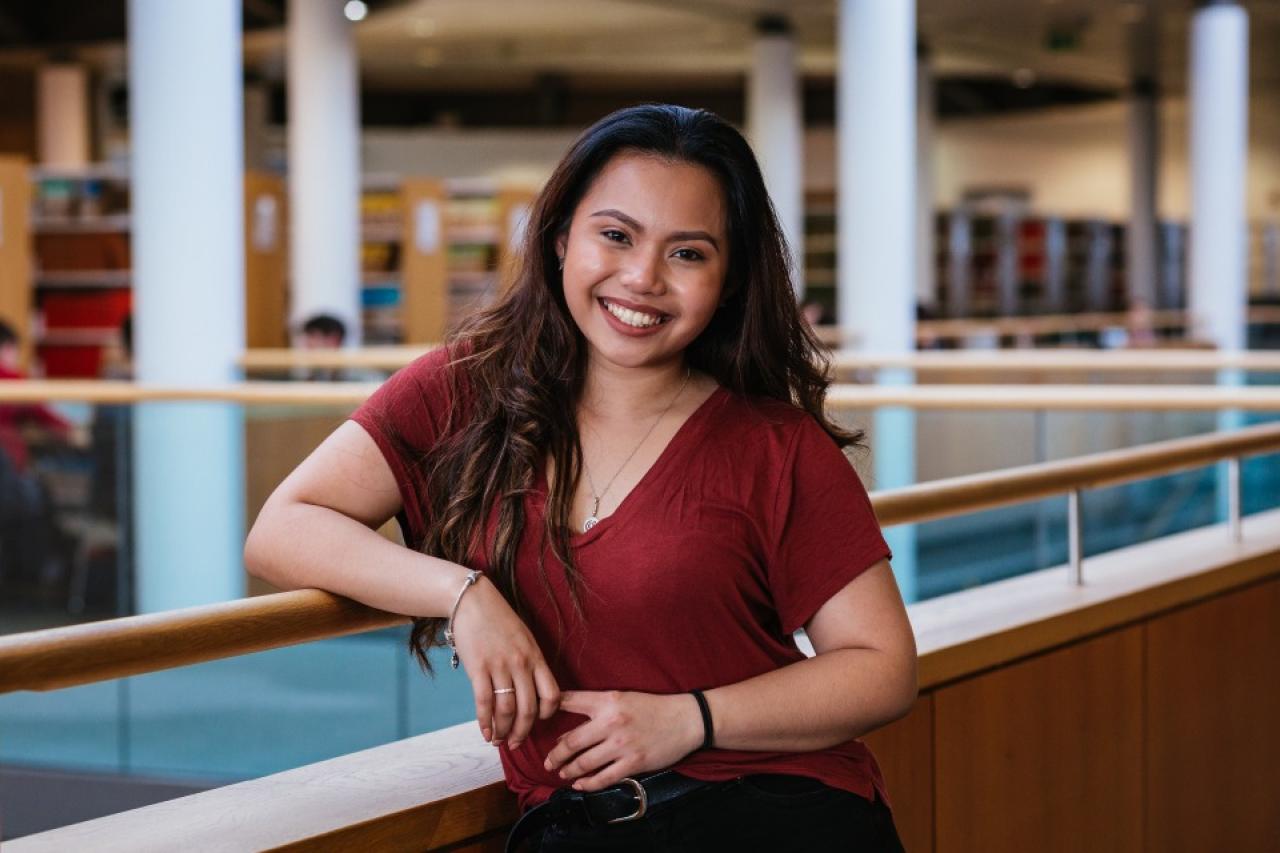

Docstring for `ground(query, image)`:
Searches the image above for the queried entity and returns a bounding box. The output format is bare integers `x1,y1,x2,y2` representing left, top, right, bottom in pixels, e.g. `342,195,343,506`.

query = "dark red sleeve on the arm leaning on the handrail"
351,347,452,549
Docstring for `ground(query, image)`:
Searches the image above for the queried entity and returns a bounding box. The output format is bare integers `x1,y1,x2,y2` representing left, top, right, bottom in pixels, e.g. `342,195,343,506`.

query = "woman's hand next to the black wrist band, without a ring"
544,690,703,792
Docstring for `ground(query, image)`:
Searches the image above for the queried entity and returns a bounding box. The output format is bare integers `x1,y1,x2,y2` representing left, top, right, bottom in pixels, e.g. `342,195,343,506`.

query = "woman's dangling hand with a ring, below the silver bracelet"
453,575,561,749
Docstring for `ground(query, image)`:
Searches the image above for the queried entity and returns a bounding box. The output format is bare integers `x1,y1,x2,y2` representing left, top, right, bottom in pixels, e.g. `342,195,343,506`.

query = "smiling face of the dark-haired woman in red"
557,152,728,368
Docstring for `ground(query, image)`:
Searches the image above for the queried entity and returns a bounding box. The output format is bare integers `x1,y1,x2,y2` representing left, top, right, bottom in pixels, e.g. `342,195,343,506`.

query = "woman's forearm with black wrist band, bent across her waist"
694,648,916,752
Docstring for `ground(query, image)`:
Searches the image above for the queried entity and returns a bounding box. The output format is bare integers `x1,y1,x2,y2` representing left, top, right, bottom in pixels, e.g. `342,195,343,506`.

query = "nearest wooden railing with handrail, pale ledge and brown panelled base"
0,425,1280,853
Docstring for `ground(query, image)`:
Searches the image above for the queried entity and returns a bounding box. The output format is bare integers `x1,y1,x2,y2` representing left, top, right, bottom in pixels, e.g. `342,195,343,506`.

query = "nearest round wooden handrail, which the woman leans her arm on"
0,424,1280,694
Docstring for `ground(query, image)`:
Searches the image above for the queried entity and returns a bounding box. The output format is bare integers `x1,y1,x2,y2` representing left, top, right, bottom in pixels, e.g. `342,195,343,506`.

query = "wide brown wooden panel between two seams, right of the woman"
933,626,1143,853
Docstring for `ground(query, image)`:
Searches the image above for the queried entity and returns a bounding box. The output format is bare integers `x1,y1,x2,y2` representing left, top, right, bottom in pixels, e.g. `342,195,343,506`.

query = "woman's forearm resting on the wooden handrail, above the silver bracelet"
244,502,467,616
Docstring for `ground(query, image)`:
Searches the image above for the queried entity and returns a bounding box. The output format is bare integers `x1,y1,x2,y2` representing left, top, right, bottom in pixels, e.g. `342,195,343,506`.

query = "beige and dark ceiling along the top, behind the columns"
0,0,1280,106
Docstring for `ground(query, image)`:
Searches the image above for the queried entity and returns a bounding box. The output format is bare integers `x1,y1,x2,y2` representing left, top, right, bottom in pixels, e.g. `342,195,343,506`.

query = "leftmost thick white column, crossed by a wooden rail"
128,0,244,611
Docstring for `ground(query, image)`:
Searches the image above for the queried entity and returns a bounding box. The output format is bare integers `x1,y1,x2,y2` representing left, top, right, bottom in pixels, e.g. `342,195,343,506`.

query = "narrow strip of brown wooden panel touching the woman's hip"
863,693,933,853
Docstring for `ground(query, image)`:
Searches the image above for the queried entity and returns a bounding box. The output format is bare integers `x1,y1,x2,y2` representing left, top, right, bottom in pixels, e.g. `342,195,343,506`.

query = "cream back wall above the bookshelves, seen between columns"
350,96,1280,219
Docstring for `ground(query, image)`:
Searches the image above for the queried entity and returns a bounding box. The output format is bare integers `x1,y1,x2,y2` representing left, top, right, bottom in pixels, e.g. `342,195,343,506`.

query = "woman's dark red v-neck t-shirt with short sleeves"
352,350,890,808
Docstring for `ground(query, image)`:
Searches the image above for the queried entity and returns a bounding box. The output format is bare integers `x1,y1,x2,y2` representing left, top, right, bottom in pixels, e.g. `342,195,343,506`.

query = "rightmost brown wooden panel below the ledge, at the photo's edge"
1147,580,1280,853
